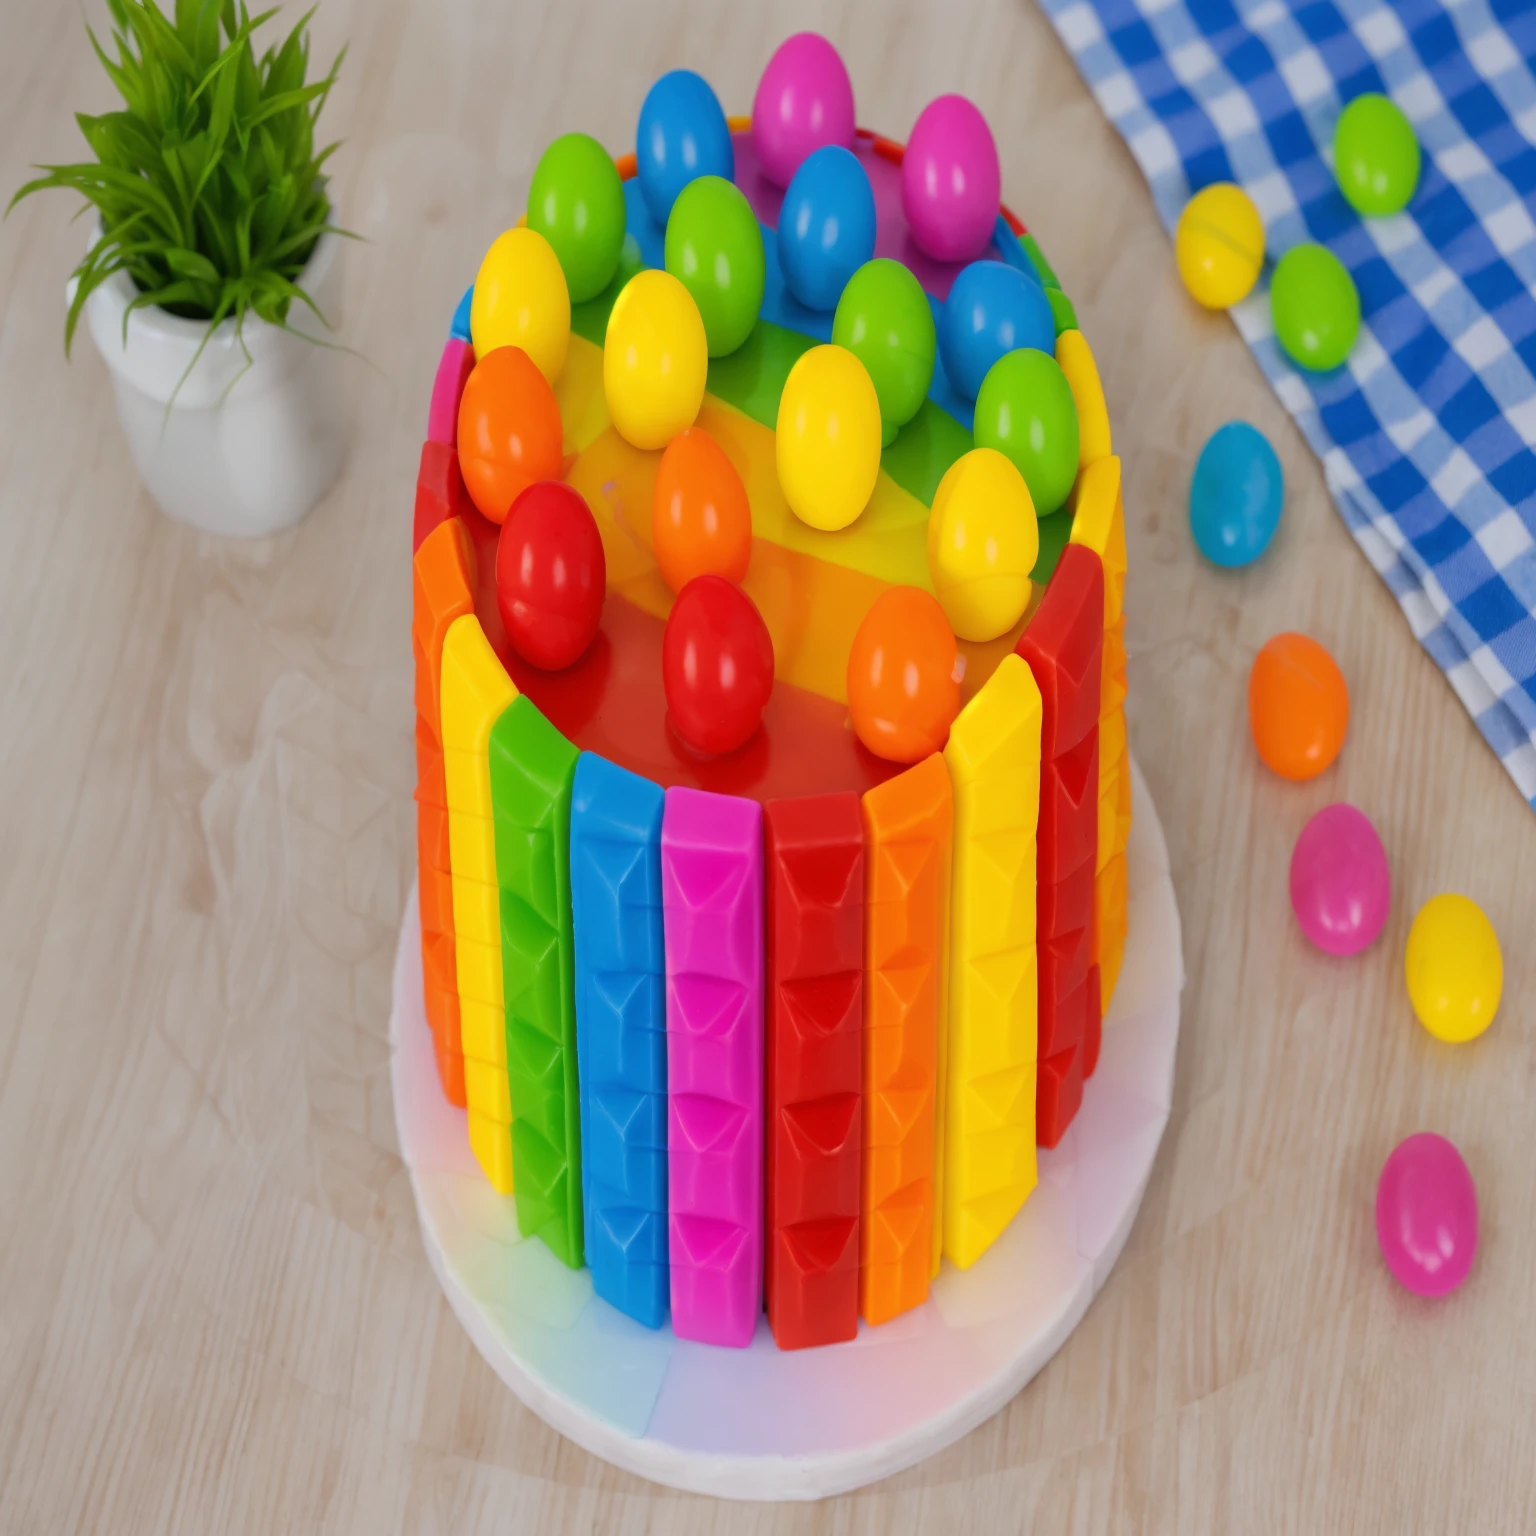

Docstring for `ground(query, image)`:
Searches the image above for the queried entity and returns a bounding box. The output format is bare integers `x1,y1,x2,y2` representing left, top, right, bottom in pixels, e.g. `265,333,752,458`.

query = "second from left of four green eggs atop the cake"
665,177,766,358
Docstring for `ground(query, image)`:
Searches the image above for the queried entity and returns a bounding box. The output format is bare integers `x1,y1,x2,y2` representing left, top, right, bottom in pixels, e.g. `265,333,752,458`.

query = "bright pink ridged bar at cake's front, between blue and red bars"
662,788,763,1349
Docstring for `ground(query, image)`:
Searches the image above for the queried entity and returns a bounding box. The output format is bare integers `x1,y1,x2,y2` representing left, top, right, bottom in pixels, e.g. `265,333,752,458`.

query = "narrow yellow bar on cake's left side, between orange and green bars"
442,614,518,1195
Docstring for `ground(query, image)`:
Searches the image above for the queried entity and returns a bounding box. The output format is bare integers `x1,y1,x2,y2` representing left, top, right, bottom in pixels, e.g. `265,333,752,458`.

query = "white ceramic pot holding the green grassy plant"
86,224,346,539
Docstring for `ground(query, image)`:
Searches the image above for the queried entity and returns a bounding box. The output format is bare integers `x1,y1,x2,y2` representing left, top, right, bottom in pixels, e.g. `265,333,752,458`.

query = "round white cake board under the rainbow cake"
390,765,1184,1499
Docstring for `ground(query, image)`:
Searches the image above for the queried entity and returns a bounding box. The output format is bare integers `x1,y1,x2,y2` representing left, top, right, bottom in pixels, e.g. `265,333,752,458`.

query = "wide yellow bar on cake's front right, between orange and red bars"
943,656,1041,1269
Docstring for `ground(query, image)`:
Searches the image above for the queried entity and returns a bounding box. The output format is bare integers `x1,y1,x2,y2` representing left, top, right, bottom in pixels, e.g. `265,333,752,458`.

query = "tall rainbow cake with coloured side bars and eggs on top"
413,34,1130,1349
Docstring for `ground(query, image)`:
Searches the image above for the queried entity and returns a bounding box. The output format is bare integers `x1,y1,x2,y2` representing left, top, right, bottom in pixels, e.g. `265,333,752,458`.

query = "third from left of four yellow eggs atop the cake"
774,344,880,531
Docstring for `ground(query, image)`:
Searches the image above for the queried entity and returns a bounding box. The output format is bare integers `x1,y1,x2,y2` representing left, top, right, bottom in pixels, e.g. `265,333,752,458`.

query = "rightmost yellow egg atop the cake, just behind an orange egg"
928,449,1040,641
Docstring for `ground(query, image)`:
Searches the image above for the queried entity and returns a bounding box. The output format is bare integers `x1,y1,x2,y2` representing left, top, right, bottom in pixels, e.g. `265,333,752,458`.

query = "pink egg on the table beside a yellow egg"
1290,805,1392,955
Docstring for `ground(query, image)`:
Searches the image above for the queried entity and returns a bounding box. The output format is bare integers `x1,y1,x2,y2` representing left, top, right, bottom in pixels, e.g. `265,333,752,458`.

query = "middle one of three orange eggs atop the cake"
651,427,753,591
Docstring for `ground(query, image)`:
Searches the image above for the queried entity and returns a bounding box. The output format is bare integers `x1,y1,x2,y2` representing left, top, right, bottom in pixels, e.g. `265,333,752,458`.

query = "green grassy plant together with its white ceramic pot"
8,0,344,536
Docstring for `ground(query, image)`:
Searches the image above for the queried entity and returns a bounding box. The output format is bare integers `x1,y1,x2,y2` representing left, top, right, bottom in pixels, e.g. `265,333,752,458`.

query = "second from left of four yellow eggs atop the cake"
602,270,710,449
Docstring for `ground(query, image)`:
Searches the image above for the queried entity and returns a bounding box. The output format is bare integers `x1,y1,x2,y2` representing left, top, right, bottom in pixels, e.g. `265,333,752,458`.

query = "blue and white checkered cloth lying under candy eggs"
1041,0,1536,808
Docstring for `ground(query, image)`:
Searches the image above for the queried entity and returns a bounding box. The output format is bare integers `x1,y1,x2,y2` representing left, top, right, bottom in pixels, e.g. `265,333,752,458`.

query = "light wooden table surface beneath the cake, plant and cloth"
0,0,1536,1536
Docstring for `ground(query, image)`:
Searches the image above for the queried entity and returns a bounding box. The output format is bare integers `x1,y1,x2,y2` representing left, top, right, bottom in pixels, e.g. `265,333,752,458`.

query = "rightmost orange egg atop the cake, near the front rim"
848,587,960,763
